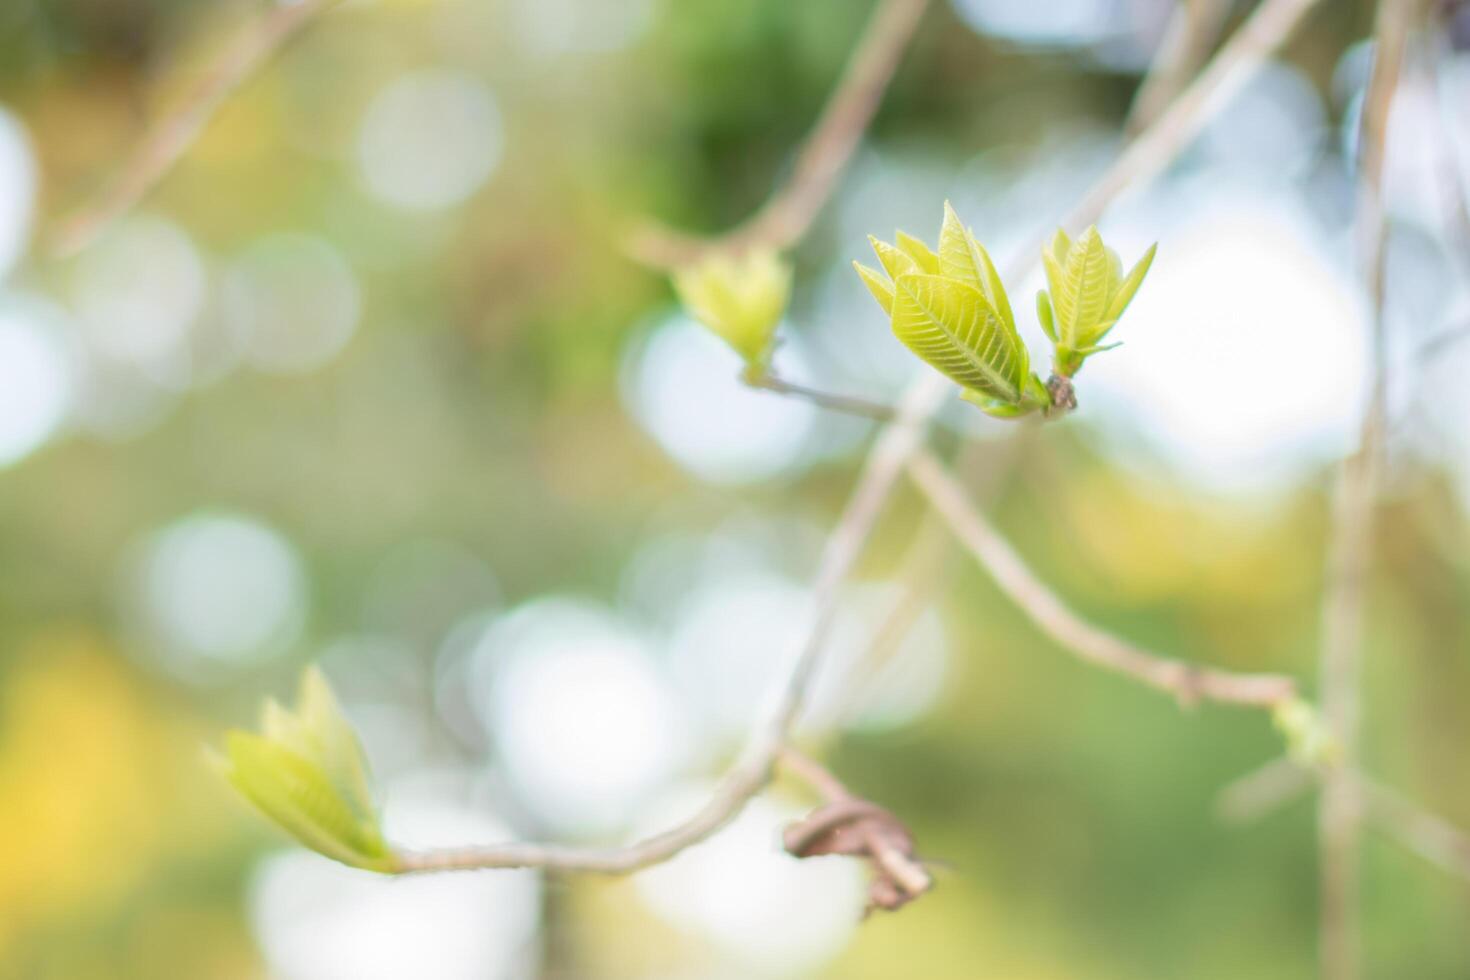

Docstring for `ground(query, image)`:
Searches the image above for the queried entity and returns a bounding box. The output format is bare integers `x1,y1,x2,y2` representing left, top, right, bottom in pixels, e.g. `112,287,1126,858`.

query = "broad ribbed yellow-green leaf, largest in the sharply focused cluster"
892,273,1029,404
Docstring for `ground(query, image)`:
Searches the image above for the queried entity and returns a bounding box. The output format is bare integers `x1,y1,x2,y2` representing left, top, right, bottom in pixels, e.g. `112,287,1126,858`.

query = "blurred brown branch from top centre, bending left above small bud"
625,0,929,269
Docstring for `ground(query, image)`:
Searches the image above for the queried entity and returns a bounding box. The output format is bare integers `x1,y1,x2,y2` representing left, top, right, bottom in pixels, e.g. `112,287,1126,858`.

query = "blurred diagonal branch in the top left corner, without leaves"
50,0,340,256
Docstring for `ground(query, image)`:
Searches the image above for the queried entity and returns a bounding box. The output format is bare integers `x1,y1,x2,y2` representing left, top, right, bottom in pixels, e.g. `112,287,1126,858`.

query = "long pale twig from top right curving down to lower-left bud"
400,0,1316,873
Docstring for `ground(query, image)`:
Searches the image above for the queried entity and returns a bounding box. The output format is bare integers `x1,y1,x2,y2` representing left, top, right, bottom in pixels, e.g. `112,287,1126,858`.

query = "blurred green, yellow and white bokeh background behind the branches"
0,0,1470,980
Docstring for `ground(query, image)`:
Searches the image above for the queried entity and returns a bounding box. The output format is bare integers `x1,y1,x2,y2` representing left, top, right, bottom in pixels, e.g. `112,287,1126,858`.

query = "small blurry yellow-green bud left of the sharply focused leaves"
673,248,791,370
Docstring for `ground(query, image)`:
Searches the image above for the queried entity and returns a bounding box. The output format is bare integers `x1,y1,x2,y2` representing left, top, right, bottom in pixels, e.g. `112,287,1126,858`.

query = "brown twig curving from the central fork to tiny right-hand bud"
908,451,1297,708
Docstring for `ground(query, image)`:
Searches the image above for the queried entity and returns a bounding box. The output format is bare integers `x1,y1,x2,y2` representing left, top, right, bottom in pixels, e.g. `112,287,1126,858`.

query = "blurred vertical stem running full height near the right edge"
1317,0,1414,980
